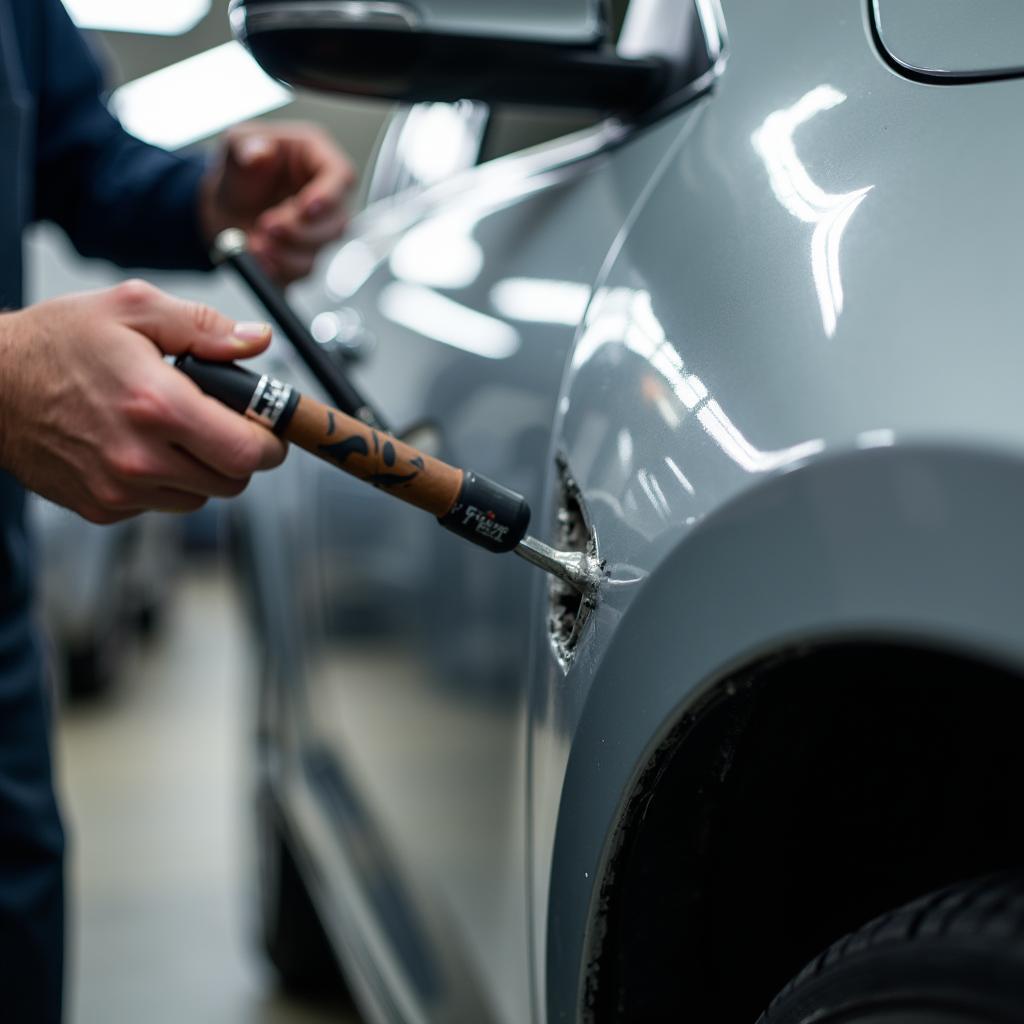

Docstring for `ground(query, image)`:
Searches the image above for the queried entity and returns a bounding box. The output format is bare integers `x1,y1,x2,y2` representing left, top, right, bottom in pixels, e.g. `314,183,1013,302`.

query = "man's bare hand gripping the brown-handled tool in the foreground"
0,281,287,523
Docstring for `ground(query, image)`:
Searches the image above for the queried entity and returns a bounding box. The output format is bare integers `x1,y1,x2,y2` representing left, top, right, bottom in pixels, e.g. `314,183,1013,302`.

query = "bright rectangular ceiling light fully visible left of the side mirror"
111,43,292,150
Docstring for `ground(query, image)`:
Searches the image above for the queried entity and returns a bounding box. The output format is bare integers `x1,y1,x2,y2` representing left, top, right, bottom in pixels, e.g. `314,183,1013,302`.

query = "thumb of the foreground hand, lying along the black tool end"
110,281,271,361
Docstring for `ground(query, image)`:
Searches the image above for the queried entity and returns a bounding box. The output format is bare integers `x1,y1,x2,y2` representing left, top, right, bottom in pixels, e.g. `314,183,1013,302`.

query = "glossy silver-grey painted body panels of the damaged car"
239,0,1024,1024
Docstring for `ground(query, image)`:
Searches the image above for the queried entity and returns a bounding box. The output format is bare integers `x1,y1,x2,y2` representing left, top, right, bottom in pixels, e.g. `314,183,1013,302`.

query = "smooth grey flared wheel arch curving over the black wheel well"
543,446,1024,1021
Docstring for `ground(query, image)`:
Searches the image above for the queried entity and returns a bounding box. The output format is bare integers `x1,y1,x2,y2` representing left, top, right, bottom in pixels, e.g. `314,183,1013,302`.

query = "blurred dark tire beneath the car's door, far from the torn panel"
257,796,351,1005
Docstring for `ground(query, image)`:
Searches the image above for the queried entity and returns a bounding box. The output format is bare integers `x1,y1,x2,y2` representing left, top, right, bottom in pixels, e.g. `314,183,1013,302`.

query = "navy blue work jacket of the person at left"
0,0,208,647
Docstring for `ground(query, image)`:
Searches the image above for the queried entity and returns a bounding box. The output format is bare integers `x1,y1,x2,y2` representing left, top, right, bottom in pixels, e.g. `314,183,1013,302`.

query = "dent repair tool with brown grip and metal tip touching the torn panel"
175,355,604,595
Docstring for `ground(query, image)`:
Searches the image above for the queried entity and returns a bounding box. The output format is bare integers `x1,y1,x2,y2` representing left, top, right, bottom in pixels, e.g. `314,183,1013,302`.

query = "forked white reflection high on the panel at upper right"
751,85,873,338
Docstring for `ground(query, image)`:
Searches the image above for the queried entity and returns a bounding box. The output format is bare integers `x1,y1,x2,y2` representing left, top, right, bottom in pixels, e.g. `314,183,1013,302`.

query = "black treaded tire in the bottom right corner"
759,872,1024,1024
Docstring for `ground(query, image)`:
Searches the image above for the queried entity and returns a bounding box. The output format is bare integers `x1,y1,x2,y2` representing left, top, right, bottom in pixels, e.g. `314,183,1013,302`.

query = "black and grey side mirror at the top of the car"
230,0,671,112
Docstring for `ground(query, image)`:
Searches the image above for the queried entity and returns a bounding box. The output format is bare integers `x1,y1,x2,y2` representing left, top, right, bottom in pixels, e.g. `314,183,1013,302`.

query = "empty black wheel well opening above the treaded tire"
587,643,1024,1024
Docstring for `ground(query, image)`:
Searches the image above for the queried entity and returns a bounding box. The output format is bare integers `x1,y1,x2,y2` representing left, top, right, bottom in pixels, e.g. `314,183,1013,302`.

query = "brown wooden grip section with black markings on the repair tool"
283,394,463,518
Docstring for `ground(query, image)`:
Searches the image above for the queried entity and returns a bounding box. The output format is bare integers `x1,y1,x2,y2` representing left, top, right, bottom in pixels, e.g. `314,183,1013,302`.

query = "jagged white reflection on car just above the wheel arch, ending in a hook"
572,288,825,475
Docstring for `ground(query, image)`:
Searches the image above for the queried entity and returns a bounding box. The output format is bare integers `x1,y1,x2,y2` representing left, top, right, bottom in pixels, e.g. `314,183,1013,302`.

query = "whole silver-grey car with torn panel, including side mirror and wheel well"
228,0,1024,1024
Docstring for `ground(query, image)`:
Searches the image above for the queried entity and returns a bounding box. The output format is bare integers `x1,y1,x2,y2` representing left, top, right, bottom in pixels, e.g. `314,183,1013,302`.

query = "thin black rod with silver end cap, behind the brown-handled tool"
211,228,387,430
